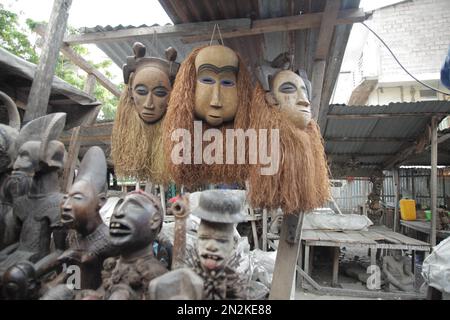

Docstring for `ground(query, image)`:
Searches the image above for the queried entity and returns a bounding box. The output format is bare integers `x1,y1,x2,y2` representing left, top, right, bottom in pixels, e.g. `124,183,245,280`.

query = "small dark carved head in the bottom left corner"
3,262,39,300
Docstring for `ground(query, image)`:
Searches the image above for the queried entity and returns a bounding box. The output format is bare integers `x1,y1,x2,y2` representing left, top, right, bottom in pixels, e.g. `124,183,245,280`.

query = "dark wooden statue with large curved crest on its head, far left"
0,113,66,282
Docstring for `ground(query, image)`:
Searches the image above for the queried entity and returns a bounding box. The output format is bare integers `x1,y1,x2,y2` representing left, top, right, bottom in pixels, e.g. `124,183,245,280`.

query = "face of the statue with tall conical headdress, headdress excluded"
61,180,100,233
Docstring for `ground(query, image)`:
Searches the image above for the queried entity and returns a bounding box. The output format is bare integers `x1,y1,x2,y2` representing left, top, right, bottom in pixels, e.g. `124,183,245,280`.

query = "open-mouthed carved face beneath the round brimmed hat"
197,220,234,270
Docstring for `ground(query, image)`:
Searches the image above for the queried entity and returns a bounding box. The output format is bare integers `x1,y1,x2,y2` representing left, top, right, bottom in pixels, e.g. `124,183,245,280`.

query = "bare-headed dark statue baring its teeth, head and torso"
102,191,167,300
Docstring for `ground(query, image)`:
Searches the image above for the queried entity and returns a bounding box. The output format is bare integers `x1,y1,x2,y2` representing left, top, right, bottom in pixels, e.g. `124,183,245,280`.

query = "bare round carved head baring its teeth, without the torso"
109,191,164,254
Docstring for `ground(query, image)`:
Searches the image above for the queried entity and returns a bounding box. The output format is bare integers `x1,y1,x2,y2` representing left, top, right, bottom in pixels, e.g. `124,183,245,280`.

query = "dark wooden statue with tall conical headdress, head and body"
28,147,117,299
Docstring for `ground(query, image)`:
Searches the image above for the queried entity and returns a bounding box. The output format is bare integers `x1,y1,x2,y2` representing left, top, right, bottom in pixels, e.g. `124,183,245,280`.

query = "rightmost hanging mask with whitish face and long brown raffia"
249,54,330,214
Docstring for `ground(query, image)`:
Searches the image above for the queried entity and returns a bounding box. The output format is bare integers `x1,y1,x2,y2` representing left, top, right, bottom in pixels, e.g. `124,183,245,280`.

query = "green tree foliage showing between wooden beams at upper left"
0,4,118,120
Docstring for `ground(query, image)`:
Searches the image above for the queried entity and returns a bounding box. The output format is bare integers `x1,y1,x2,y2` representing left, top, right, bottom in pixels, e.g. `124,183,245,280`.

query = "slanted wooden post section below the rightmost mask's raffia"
269,213,303,300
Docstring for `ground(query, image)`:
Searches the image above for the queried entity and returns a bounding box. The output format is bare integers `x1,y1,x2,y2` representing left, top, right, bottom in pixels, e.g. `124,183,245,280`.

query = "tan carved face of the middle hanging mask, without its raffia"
194,46,239,127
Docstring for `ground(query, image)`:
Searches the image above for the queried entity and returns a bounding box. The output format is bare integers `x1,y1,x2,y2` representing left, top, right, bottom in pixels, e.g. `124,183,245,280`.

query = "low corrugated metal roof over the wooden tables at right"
324,101,450,172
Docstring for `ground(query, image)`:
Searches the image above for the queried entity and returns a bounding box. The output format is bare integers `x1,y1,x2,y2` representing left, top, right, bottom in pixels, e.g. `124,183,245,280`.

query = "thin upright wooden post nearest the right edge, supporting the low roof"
430,117,438,247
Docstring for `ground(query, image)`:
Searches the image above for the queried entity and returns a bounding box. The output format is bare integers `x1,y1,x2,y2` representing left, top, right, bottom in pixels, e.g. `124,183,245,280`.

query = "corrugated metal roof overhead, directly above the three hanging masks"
82,0,359,89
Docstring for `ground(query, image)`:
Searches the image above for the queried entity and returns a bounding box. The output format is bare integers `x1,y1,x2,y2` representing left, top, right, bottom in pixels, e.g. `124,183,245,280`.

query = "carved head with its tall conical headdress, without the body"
61,147,107,235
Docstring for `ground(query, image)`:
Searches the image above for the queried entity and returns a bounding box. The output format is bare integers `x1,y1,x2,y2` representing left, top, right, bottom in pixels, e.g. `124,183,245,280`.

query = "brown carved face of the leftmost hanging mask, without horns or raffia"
131,64,172,123
